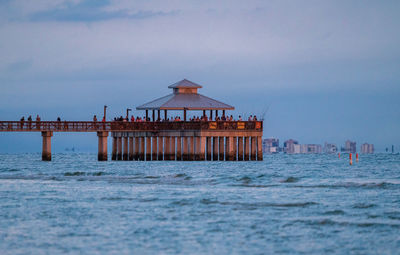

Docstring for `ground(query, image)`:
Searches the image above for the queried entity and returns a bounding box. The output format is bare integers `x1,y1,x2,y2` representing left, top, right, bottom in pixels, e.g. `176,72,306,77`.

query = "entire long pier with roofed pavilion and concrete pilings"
0,80,263,161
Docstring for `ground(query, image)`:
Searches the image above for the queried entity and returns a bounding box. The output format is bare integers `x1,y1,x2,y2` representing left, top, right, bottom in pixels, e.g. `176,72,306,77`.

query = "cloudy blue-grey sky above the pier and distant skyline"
0,0,400,153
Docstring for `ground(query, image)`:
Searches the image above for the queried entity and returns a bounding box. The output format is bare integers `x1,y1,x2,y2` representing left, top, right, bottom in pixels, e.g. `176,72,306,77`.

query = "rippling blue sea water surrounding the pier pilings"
0,154,400,254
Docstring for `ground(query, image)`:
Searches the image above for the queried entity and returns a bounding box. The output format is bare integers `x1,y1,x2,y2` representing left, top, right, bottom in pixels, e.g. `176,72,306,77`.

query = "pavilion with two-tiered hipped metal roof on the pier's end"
136,79,235,121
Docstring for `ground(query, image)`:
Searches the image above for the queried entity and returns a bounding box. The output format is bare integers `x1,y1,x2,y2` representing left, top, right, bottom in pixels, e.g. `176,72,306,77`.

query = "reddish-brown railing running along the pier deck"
0,121,263,132
